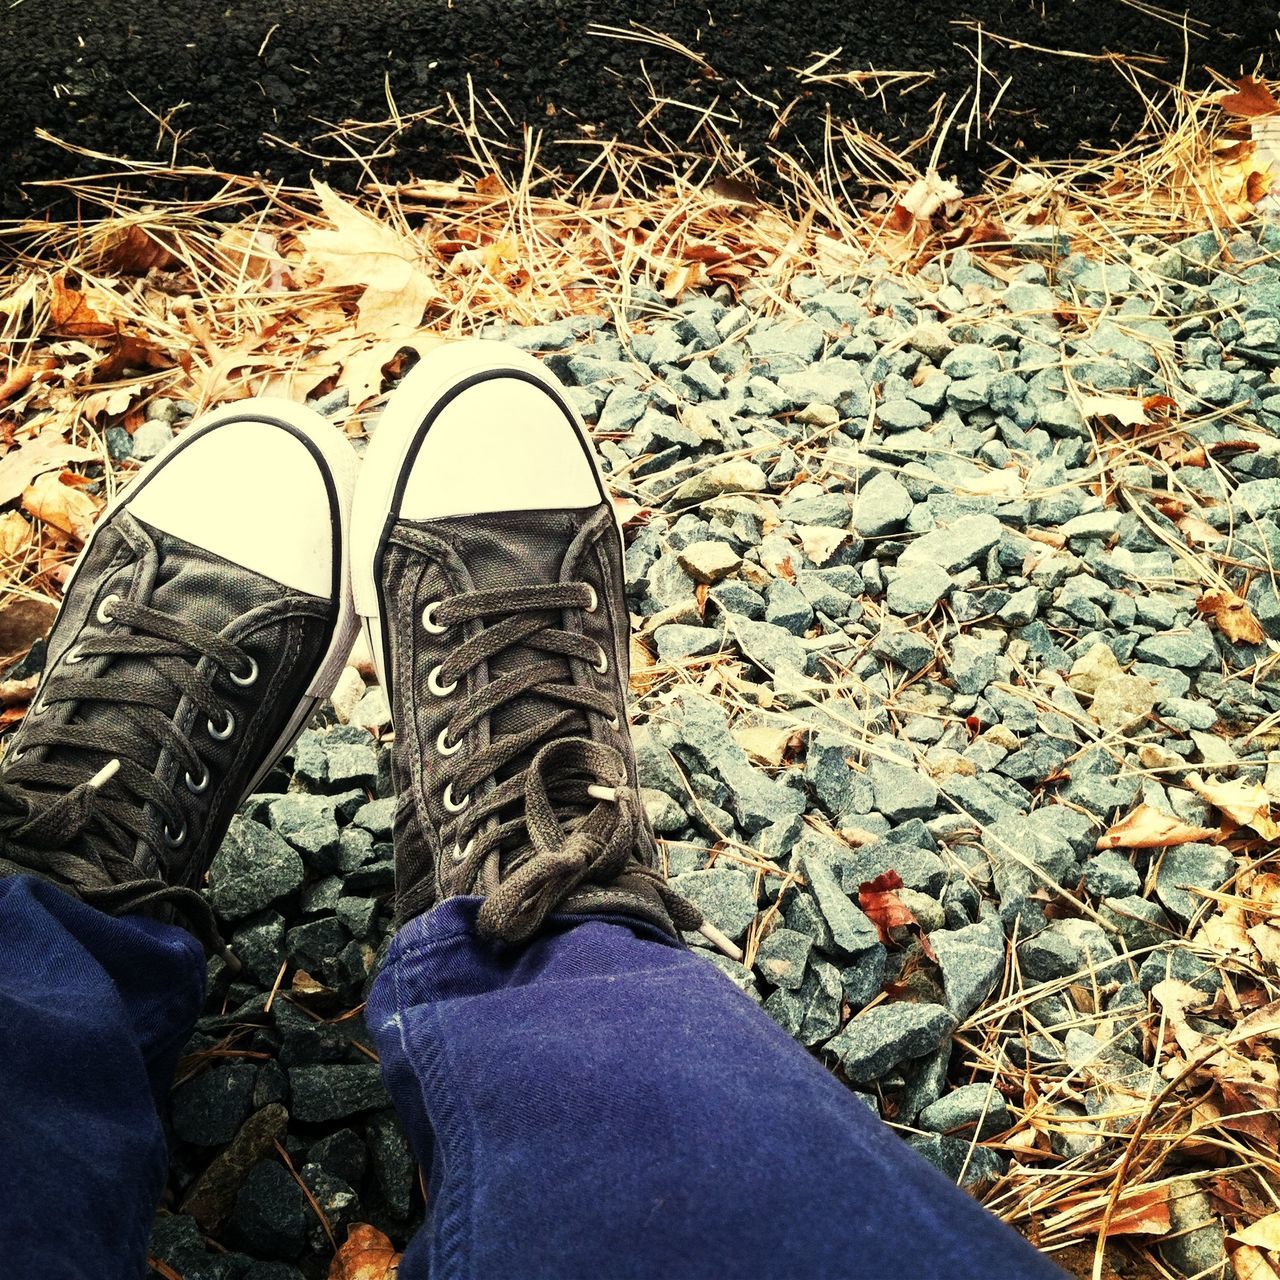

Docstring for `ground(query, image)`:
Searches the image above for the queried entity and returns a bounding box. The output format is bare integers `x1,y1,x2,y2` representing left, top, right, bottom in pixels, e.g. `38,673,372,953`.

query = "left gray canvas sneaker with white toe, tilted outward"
0,399,357,945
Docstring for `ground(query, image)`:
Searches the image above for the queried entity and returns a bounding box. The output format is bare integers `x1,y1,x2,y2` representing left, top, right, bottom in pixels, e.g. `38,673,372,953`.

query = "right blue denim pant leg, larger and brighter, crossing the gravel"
366,899,1062,1280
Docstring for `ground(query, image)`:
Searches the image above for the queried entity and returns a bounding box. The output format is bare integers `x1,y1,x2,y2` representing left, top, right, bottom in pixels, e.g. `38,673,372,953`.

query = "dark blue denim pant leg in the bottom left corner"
0,876,205,1280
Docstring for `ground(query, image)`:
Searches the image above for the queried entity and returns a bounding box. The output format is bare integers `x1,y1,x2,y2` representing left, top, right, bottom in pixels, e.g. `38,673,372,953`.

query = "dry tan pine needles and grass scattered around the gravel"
0,62,1280,1277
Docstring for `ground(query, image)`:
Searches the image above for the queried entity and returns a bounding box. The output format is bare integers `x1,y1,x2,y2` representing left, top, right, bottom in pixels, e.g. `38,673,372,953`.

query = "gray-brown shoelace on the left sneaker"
0,596,257,950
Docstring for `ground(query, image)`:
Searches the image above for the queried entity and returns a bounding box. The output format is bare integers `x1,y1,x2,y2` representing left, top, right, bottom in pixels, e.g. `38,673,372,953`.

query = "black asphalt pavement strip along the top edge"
0,0,1280,216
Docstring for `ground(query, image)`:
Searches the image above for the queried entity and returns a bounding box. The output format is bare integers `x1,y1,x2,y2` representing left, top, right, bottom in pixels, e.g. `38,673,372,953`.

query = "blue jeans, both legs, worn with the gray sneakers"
0,878,1061,1280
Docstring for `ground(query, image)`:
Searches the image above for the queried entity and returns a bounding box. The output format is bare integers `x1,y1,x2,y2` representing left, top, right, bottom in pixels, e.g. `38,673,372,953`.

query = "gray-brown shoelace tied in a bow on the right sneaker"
422,582,740,955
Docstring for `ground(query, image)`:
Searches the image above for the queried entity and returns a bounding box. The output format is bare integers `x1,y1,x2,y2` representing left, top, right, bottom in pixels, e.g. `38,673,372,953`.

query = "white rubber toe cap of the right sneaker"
399,374,603,520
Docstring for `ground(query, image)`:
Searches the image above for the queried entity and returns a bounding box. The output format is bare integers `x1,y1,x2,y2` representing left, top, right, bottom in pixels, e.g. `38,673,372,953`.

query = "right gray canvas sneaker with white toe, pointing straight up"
352,340,723,942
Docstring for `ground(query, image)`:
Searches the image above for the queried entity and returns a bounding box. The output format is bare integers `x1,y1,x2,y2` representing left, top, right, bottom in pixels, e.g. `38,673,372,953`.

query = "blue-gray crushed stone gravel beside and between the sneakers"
145,212,1280,1277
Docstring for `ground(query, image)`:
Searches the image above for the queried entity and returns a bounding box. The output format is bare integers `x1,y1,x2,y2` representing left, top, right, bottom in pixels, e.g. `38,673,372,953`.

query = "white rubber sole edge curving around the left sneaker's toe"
54,397,360,797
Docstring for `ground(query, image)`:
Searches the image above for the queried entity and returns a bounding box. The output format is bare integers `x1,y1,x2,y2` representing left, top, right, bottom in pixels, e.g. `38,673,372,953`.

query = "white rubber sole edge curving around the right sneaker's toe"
351,338,622,700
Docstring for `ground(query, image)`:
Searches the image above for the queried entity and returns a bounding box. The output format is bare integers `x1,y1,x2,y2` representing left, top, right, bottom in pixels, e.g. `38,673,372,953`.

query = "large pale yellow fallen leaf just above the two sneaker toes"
298,182,439,334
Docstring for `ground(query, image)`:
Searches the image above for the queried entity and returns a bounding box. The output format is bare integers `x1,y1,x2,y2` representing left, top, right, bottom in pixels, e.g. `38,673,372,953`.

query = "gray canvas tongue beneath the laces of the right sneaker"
427,508,594,782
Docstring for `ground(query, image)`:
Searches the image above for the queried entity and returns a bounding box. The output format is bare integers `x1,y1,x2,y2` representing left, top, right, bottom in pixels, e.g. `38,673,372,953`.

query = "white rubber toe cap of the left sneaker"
125,406,349,599
